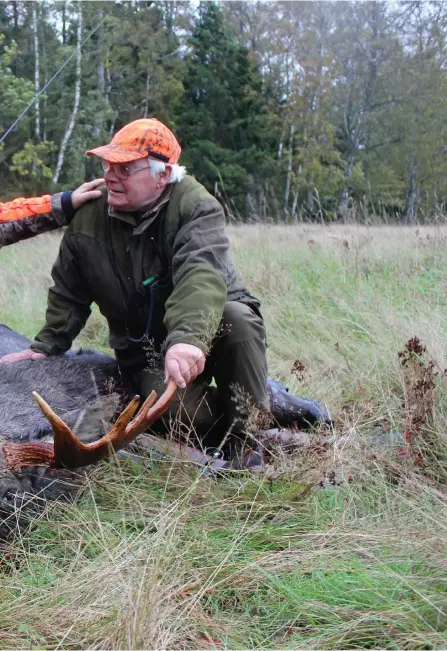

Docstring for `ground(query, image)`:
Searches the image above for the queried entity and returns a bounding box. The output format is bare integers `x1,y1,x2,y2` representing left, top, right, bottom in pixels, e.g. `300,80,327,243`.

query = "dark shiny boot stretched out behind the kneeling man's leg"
267,378,332,429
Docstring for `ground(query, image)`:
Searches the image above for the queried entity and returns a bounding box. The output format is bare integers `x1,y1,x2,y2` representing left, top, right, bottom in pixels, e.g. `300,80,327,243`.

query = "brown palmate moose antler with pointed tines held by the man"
3,380,177,470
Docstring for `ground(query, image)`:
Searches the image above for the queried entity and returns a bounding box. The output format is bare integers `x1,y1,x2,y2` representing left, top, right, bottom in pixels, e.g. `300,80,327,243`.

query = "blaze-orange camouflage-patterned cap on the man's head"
85,118,182,164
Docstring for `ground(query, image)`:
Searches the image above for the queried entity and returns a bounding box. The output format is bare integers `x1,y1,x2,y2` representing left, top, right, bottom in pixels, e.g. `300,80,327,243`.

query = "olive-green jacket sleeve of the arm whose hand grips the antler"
164,196,232,352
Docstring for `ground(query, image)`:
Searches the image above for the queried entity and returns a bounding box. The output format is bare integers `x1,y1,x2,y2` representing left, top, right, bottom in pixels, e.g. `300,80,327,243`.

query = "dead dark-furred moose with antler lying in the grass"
0,324,184,538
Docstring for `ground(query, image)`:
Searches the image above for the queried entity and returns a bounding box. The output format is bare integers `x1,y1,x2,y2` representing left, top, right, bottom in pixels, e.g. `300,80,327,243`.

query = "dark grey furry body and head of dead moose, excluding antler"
0,324,122,539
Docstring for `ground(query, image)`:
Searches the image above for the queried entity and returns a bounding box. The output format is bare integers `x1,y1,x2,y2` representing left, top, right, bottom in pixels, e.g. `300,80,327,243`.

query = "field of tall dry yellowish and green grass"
0,226,447,649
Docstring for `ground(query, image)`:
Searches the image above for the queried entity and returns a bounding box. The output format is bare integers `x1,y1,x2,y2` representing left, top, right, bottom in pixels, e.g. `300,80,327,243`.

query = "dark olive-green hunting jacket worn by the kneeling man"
31,176,259,365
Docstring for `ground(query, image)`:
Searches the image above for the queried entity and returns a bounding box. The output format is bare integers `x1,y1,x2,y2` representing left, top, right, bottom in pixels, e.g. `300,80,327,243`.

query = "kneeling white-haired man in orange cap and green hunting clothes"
0,119,328,454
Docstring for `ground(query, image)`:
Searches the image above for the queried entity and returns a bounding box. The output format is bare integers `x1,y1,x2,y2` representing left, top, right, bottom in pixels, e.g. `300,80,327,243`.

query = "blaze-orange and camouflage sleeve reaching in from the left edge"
0,192,74,248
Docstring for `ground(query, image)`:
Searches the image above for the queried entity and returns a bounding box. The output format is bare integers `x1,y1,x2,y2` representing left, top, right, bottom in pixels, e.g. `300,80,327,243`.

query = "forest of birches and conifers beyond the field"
0,0,447,224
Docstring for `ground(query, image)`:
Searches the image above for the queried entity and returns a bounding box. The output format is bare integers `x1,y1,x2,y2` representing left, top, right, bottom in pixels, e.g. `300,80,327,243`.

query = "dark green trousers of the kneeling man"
131,301,267,447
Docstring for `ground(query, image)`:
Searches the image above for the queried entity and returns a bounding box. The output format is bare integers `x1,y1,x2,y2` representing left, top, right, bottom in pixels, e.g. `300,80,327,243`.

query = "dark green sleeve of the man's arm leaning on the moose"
30,229,92,355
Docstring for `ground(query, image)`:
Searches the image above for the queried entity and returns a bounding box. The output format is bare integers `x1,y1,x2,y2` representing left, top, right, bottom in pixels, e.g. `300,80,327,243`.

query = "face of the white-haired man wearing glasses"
104,158,167,212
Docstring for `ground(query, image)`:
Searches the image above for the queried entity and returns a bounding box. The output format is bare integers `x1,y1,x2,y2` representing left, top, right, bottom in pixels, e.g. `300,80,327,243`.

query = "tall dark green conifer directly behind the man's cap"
178,2,276,215
